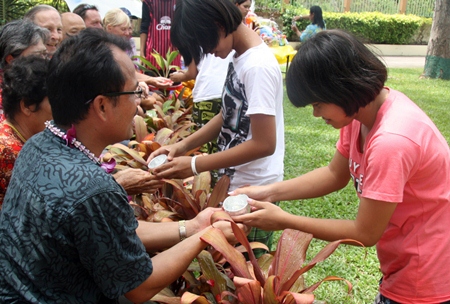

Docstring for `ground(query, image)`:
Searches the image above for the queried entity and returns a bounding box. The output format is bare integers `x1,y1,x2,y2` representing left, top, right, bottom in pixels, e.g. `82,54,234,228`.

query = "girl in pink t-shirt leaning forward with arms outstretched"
233,30,450,304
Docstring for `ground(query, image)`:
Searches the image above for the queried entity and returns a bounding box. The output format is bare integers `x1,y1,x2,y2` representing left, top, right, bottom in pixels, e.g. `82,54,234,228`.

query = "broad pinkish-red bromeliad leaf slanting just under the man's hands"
200,228,253,279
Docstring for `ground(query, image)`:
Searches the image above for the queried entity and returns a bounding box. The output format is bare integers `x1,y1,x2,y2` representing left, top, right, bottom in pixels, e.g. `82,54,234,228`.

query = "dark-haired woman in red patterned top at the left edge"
0,55,52,208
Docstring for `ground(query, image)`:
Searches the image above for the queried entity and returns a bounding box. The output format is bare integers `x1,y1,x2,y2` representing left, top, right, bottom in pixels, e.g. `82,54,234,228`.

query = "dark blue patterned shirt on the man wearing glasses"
0,129,153,303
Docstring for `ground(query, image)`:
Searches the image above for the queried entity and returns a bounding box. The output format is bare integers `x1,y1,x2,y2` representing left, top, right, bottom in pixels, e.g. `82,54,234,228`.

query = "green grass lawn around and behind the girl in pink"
273,69,450,304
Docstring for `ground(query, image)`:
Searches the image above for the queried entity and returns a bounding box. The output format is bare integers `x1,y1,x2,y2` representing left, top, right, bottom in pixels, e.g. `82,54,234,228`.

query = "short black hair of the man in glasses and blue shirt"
47,28,129,126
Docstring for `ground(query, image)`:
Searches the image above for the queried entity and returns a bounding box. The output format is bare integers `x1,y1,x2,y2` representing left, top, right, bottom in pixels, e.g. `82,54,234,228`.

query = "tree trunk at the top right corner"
422,0,450,79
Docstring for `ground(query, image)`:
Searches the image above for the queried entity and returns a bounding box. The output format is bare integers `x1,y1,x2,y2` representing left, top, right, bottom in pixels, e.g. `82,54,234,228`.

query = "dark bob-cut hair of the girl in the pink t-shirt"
286,30,387,116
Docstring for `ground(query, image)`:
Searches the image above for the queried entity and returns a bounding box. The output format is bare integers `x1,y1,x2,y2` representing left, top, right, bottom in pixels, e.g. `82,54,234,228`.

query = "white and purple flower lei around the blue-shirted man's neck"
45,121,116,173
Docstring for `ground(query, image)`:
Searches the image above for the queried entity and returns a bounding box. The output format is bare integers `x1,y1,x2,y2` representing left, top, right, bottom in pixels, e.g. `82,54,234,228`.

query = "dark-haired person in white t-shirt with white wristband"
150,0,284,255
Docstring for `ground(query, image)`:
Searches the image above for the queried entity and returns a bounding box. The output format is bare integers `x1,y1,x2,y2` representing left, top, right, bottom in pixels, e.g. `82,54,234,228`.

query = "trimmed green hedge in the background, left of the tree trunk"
281,7,432,44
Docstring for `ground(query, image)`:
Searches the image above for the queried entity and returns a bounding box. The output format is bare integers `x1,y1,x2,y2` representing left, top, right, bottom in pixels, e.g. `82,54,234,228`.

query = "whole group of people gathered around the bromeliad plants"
0,0,450,304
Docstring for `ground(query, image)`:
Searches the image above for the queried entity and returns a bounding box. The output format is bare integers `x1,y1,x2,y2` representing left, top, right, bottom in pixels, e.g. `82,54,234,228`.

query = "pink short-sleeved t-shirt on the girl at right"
337,90,450,304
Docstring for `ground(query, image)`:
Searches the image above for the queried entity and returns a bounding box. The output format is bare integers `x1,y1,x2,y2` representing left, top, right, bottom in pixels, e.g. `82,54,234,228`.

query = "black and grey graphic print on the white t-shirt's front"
217,62,250,180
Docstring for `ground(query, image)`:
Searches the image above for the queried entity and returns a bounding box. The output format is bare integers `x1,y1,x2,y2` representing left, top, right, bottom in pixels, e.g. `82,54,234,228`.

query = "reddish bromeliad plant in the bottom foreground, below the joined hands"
174,218,362,304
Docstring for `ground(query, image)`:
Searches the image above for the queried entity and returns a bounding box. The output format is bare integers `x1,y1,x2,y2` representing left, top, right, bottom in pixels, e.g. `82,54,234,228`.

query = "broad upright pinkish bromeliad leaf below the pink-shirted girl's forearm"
268,229,313,294
